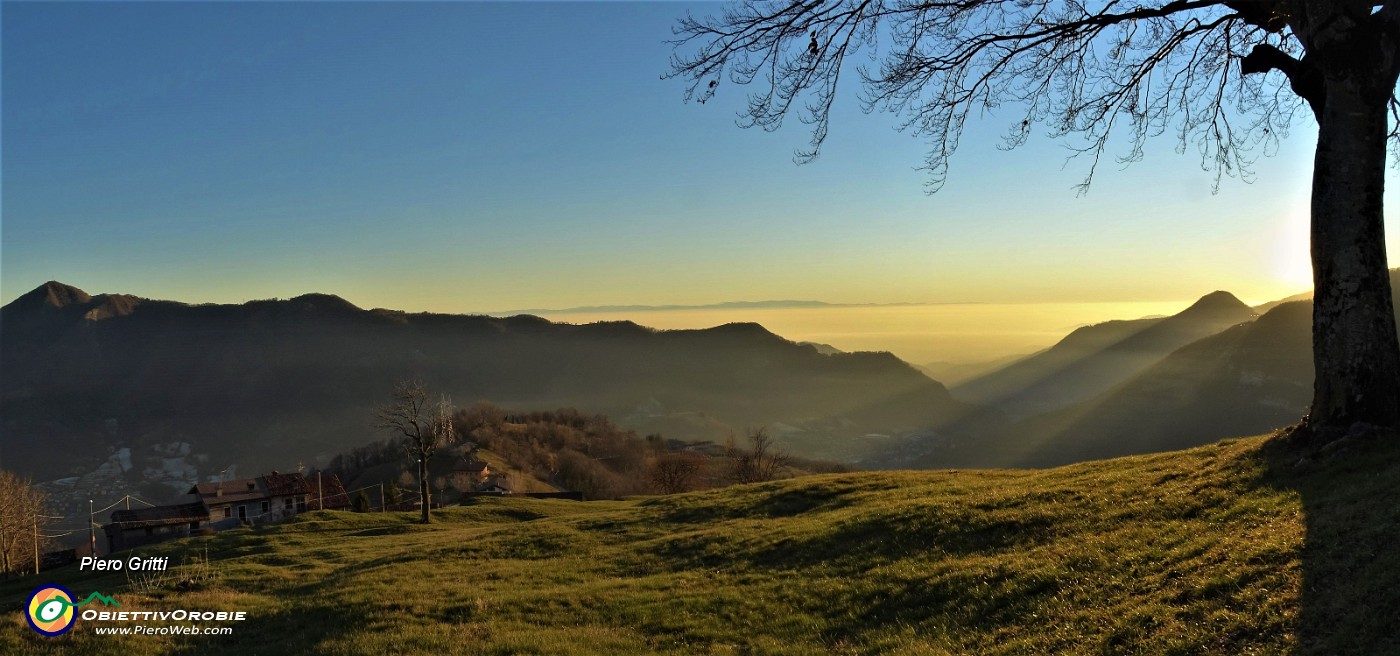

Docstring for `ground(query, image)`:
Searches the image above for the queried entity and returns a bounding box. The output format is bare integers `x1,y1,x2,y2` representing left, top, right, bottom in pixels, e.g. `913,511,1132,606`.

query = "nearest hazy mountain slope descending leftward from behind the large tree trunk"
896,270,1400,467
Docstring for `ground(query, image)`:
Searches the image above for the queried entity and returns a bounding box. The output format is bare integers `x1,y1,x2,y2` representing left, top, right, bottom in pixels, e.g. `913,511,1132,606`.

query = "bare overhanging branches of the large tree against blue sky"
666,0,1306,192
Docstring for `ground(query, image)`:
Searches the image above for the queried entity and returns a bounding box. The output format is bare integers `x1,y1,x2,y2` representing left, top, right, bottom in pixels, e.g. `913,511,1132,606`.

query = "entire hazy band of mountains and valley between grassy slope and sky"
0,271,1355,517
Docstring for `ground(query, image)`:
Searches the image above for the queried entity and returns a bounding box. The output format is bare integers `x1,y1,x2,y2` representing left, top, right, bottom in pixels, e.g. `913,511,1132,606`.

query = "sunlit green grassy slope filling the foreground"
0,438,1400,655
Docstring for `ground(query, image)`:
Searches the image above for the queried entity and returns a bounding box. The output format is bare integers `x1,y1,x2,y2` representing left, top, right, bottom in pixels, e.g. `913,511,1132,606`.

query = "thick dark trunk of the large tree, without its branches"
1308,76,1400,438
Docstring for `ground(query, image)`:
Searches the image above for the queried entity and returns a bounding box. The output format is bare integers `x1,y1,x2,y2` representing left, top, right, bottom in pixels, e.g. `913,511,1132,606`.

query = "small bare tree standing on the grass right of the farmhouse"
375,380,456,523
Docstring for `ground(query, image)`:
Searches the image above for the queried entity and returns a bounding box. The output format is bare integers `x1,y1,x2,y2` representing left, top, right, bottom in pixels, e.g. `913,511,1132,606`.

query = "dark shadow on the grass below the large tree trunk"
1261,432,1400,656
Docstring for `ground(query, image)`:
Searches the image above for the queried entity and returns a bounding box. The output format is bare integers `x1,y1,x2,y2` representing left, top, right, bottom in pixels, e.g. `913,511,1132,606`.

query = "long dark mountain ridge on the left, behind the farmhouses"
0,283,970,478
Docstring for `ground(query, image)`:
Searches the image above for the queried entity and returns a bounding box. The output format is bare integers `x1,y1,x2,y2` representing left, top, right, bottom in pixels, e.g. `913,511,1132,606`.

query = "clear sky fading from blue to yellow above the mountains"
0,3,1394,312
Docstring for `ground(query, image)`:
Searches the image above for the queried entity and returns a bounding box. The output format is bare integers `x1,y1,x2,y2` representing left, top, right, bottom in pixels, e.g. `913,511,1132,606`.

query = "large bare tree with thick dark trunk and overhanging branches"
668,0,1400,438
